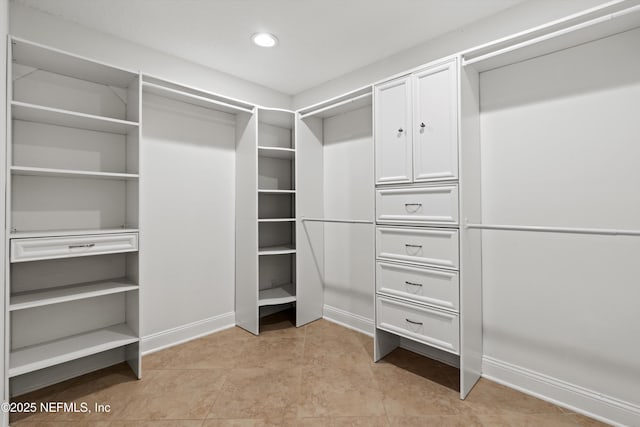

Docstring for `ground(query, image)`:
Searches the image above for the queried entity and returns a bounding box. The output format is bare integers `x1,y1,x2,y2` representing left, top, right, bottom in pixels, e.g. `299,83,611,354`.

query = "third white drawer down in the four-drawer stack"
376,261,459,311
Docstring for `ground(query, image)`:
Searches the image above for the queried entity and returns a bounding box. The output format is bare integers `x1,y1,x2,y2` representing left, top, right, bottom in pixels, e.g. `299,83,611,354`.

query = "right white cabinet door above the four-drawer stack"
412,61,458,182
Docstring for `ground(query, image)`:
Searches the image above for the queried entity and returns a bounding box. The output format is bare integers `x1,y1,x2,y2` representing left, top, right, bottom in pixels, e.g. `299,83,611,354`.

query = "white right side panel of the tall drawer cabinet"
459,62,482,399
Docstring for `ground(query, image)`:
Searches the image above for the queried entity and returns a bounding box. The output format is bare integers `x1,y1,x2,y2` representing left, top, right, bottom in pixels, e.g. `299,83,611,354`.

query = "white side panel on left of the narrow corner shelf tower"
235,114,259,334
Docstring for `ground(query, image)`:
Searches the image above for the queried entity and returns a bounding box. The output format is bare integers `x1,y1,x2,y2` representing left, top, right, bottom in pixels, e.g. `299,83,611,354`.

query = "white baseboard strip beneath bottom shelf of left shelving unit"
10,348,125,397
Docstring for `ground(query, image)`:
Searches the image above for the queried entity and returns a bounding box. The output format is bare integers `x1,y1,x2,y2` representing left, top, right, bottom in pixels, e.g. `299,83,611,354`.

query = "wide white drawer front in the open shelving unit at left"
11,233,138,262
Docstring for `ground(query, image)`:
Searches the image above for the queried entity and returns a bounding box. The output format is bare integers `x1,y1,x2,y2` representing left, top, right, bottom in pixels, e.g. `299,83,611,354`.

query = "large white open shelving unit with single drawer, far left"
5,38,141,395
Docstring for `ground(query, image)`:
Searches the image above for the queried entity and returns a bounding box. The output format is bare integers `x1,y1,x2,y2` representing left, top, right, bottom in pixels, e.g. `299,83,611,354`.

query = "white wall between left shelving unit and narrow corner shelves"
140,94,236,351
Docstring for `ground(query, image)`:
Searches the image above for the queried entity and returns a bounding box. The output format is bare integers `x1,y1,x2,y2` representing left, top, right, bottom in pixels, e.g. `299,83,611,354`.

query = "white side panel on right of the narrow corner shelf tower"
295,117,324,326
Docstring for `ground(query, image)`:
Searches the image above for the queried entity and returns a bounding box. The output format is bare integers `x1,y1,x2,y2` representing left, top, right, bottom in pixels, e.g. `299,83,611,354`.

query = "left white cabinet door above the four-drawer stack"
375,77,412,184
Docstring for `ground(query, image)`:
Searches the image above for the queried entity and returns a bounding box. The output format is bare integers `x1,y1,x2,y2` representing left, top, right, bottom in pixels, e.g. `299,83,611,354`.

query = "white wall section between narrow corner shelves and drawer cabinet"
323,106,374,332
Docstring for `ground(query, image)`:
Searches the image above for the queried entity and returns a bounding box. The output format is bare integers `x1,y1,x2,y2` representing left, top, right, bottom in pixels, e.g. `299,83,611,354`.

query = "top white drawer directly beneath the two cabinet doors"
376,184,458,225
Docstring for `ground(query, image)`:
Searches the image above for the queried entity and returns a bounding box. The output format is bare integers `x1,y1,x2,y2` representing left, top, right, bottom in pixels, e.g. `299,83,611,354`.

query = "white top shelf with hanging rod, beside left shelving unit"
142,74,255,114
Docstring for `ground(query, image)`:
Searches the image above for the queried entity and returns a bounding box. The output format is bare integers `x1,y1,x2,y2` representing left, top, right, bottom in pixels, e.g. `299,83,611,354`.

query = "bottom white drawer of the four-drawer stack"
376,297,460,354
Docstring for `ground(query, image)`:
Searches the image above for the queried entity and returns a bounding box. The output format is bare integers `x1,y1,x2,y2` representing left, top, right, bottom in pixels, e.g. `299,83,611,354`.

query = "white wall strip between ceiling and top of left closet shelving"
10,2,291,108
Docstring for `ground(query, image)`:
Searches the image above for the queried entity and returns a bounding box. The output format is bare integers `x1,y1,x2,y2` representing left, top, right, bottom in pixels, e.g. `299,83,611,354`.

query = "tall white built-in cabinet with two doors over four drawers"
374,57,482,398
